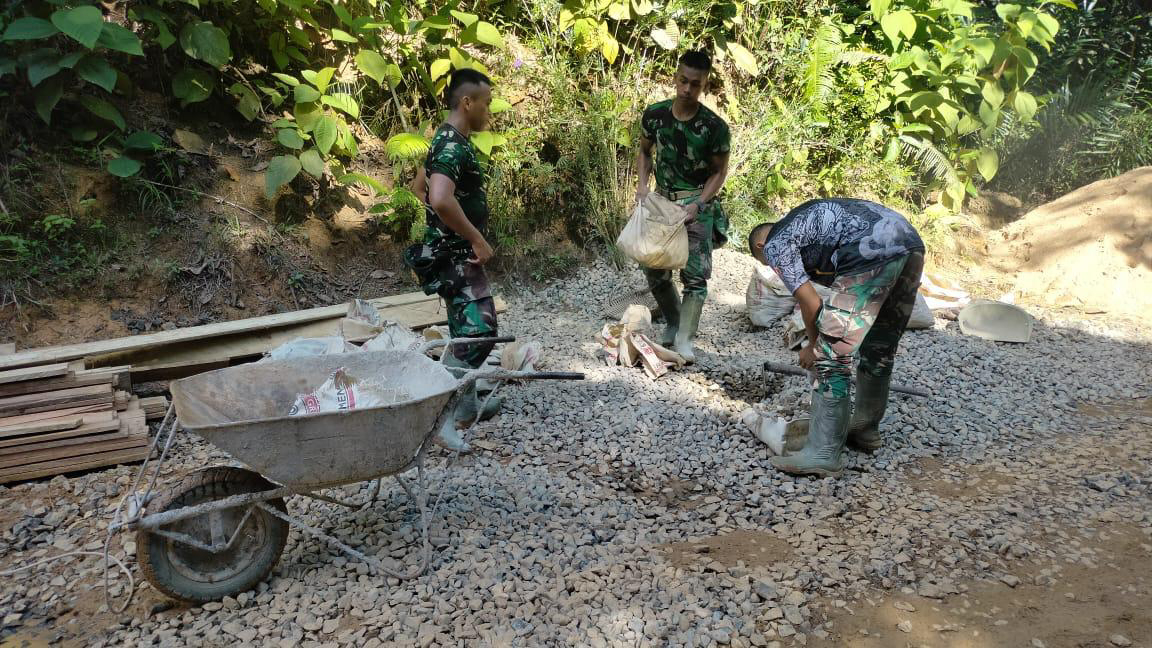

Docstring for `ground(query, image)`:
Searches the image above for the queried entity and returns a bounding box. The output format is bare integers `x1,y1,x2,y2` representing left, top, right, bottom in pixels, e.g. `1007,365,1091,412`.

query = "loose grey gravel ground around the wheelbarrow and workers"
0,250,1152,647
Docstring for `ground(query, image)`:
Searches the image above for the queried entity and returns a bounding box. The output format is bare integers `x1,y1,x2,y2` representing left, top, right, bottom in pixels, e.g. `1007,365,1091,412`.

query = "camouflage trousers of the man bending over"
814,251,924,398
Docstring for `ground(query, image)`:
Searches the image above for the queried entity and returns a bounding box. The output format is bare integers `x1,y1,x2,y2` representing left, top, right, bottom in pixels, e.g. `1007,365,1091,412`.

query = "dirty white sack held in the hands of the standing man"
616,193,688,270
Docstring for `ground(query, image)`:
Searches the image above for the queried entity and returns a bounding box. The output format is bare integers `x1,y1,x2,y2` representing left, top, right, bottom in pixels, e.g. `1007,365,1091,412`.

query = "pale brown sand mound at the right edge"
988,167,1152,316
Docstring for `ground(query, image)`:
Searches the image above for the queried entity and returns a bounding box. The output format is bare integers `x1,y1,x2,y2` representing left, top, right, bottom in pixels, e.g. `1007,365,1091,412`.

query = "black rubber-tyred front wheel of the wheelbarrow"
136,466,288,603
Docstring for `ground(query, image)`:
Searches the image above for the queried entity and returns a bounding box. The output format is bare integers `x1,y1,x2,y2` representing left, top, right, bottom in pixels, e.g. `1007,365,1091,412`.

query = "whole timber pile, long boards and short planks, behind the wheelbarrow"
0,293,503,484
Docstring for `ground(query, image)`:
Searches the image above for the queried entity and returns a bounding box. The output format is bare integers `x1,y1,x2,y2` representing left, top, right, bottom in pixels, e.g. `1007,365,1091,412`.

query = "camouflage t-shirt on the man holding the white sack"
641,99,732,191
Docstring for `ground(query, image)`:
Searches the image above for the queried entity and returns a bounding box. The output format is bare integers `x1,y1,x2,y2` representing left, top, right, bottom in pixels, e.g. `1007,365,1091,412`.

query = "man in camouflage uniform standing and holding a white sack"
636,52,732,362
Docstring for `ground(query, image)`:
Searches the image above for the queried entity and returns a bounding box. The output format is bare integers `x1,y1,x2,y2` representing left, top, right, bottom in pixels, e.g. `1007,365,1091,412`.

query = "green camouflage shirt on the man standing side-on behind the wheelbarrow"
424,123,488,250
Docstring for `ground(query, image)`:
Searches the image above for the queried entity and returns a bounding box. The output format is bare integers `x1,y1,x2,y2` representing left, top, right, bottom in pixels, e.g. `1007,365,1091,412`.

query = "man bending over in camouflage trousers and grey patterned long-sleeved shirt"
748,198,924,476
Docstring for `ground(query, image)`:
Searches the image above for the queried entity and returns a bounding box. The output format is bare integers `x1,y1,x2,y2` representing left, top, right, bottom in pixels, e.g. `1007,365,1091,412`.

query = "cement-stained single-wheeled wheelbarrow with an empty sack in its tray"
109,338,584,603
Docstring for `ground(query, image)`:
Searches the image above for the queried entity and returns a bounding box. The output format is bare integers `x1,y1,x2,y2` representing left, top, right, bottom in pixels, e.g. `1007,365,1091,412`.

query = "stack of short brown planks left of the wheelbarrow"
0,361,167,483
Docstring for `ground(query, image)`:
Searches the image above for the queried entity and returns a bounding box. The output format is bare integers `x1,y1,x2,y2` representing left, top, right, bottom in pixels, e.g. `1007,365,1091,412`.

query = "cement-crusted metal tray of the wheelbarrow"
170,351,460,489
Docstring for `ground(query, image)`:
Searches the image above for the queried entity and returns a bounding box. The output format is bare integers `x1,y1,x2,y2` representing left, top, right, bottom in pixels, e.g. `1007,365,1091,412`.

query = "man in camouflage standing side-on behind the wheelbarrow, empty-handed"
407,69,500,451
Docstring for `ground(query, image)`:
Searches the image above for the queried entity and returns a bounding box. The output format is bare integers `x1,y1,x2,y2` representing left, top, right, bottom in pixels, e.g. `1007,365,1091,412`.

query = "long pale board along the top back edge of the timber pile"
0,293,437,369
